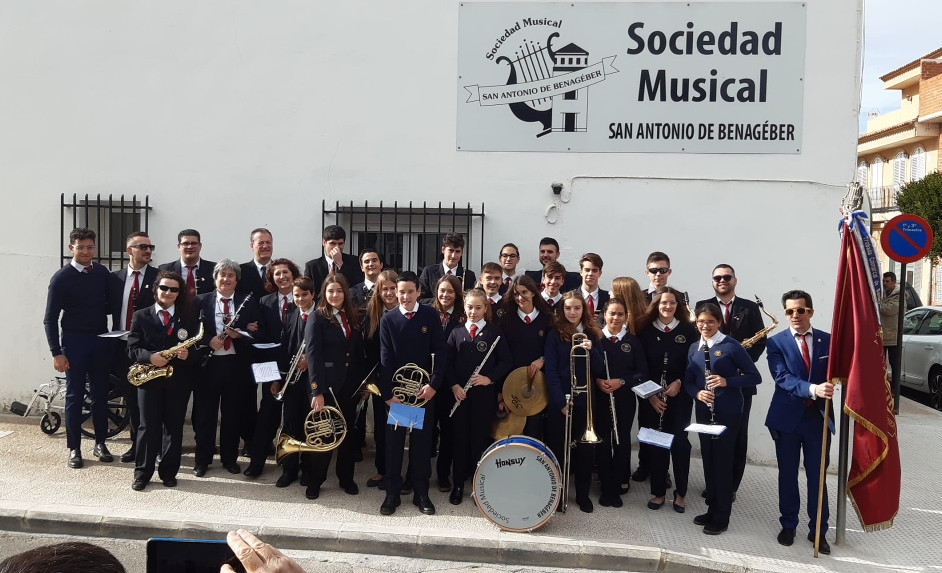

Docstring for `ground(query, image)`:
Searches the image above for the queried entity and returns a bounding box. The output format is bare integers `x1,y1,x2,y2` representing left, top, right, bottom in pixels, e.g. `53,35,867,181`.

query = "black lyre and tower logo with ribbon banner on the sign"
464,22,618,137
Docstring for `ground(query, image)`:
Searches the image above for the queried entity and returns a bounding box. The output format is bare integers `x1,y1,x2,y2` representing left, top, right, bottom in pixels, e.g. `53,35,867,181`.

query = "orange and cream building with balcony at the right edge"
856,48,942,304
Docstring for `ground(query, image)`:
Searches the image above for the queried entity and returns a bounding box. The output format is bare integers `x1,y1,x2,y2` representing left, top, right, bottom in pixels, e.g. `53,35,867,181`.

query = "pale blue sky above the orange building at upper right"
859,0,942,133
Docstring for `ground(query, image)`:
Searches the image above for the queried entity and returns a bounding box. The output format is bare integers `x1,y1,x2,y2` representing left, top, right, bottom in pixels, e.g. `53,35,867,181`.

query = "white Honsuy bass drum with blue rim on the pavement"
472,436,561,531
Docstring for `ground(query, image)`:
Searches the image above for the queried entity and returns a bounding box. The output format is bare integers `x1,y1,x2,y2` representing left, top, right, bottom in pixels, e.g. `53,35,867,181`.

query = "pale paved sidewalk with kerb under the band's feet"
0,398,942,573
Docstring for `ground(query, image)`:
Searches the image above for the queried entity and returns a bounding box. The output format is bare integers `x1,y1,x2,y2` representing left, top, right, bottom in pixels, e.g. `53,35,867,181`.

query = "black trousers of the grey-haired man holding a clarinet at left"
193,355,245,465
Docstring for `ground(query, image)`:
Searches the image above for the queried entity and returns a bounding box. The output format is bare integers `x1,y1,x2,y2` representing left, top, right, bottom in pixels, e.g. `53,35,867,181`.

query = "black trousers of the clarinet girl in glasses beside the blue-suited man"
696,402,742,527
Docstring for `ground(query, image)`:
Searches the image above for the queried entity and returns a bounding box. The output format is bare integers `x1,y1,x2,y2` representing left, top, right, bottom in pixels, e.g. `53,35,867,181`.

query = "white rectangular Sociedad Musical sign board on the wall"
457,2,807,153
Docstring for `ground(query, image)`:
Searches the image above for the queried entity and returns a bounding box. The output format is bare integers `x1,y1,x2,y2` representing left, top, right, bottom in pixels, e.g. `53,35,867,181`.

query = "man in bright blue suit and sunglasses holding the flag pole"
765,290,834,554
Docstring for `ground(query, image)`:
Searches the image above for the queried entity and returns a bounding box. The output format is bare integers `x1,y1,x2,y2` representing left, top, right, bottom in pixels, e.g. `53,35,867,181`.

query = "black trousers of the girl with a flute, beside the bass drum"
452,384,497,487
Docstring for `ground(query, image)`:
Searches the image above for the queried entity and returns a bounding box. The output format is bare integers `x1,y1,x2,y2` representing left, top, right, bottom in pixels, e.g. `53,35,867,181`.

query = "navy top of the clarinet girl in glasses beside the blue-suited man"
684,336,762,414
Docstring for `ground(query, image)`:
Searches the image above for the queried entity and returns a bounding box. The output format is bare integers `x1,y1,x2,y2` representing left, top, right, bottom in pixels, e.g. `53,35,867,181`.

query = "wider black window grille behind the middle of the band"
321,201,484,273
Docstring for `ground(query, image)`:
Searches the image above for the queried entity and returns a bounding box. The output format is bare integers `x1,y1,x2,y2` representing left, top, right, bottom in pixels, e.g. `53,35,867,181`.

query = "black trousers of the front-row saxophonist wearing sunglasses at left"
134,368,191,482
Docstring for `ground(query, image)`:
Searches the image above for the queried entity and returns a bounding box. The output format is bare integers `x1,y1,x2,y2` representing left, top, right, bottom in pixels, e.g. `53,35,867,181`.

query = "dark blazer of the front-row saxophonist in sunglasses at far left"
128,305,199,368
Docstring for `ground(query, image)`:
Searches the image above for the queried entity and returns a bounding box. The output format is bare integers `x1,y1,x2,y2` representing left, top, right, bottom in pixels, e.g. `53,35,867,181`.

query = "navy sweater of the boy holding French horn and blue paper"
379,304,448,400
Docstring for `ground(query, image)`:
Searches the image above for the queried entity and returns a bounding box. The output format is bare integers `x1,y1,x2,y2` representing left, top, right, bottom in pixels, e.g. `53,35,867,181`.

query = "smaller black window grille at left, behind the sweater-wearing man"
59,193,151,270
